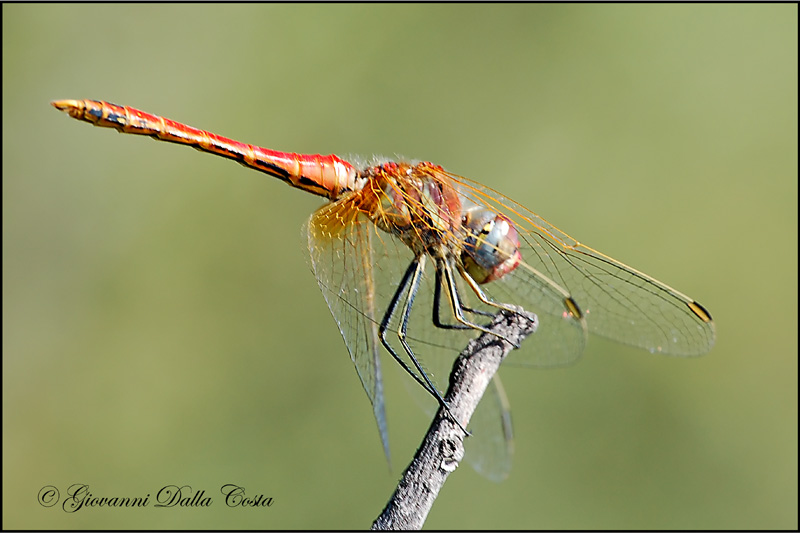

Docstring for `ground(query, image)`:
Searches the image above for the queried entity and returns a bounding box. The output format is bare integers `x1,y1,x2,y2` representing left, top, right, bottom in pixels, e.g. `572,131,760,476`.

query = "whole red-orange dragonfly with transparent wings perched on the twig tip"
52,100,715,478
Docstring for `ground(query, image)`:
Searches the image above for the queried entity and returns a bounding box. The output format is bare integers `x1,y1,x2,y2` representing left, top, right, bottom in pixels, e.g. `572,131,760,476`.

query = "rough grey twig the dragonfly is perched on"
372,310,538,530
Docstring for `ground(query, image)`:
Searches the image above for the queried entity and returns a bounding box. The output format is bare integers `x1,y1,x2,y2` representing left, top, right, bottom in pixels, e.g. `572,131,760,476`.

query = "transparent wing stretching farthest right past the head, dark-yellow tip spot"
447,174,715,364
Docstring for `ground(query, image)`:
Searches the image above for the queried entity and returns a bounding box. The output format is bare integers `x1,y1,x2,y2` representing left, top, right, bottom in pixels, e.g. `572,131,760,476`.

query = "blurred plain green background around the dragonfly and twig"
3,5,798,529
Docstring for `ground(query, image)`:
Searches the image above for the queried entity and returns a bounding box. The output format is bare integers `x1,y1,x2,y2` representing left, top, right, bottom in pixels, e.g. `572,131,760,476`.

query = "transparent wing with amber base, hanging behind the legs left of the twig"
306,195,482,459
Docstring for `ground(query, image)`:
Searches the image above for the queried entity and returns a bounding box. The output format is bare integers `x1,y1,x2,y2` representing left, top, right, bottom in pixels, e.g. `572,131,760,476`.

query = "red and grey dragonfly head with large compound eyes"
461,207,522,283
